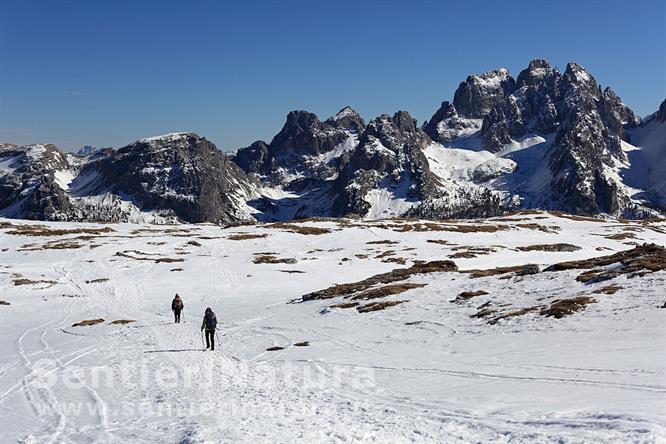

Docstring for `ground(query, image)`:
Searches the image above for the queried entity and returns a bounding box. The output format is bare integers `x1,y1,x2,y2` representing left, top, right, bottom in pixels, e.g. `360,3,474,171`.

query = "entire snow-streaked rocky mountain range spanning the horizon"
0,60,666,223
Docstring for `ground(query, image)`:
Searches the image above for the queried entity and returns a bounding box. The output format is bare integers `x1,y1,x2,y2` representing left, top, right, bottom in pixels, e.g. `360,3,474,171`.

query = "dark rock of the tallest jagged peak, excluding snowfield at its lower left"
424,60,641,216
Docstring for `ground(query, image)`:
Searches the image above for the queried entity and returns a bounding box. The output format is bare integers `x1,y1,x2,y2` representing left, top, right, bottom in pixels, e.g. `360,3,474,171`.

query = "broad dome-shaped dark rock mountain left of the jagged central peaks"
74,133,255,223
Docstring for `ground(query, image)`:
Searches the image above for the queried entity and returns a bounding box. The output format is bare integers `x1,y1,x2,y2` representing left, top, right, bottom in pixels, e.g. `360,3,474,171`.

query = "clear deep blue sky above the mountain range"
0,0,666,150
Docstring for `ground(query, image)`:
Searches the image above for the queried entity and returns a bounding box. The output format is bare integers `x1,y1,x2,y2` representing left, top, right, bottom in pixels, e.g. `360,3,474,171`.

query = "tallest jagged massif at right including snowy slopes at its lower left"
423,60,663,217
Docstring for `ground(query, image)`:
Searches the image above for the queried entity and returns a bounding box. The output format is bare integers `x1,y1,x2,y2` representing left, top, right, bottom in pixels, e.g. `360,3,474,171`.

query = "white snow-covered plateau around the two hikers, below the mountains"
0,213,666,443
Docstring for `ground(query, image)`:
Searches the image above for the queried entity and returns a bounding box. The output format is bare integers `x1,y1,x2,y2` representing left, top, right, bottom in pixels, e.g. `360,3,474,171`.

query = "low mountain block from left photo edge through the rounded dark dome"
0,133,252,223
